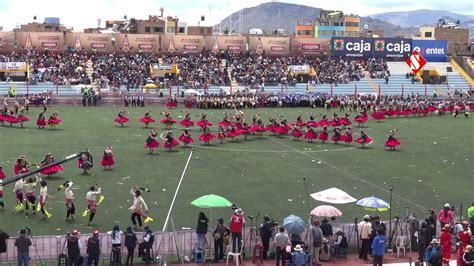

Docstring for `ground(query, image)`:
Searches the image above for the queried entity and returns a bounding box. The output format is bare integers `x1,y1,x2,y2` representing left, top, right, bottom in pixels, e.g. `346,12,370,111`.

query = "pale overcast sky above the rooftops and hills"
0,0,474,30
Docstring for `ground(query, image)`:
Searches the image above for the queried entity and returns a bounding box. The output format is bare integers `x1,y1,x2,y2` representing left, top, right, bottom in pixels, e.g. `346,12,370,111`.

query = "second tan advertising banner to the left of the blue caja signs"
249,37,290,56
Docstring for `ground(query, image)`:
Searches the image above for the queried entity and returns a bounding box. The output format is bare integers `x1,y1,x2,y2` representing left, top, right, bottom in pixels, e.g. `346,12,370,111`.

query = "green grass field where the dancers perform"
0,107,474,234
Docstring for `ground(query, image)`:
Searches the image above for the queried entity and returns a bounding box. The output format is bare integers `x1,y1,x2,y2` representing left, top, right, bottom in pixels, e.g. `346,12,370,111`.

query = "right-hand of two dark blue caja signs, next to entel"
373,38,413,59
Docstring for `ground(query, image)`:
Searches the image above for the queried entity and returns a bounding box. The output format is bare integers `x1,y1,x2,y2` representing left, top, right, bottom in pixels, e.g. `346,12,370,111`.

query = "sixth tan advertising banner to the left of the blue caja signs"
66,32,113,53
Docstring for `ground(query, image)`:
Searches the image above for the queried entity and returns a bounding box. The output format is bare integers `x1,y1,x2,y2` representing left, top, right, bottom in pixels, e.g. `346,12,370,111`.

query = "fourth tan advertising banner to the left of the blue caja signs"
161,35,204,54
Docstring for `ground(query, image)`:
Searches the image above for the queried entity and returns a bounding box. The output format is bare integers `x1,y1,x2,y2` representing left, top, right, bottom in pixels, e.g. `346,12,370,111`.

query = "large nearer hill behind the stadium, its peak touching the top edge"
214,2,419,37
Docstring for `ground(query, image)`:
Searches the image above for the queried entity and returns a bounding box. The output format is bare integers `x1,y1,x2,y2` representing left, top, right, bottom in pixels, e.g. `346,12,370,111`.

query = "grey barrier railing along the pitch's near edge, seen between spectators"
0,219,408,265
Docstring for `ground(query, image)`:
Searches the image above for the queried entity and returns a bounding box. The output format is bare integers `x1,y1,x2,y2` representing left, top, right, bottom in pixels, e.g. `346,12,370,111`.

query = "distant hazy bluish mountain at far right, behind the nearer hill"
369,9,474,27
